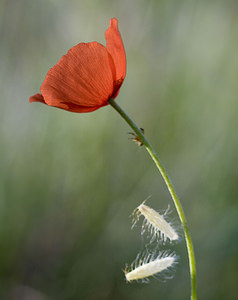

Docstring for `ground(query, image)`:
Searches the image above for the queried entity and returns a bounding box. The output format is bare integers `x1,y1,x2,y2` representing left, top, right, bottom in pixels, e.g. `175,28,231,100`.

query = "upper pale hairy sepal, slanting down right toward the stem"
132,201,179,241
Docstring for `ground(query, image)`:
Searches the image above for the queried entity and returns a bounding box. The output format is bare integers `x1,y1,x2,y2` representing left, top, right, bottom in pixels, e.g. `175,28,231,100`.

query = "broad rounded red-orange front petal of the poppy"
41,42,113,112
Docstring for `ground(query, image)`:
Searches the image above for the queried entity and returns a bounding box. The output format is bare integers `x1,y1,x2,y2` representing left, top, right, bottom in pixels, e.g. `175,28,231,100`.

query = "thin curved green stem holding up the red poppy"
108,98,197,300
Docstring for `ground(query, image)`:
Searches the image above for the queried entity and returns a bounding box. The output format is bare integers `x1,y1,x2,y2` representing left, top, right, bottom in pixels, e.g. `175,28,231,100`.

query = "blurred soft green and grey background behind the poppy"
0,0,238,300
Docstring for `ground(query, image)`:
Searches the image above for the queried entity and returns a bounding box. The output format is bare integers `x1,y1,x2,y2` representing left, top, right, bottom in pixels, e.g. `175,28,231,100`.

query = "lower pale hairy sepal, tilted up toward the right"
124,252,177,282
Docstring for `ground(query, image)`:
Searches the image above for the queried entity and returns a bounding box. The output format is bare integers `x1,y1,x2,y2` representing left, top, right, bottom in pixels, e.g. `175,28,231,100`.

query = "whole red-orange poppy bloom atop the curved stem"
30,18,126,113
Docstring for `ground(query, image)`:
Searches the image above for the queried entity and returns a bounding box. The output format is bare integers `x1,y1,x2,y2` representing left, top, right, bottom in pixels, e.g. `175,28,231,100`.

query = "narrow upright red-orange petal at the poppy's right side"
105,18,126,85
